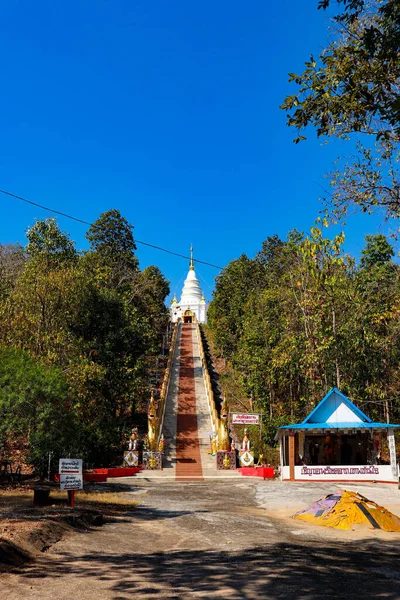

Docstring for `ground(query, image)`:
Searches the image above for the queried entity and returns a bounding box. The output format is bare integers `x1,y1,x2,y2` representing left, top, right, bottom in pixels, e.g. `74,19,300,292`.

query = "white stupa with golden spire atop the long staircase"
171,247,207,323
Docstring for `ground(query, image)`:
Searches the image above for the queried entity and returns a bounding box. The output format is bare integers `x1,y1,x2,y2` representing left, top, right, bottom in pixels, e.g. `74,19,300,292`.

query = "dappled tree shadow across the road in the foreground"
12,542,400,600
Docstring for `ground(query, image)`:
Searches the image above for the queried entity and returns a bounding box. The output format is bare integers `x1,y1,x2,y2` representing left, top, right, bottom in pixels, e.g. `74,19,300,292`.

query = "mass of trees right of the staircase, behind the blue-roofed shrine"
208,227,400,442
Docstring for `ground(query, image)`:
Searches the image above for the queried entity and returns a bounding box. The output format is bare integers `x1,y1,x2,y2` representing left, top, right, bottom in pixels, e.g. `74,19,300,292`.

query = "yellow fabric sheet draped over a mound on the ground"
294,490,400,532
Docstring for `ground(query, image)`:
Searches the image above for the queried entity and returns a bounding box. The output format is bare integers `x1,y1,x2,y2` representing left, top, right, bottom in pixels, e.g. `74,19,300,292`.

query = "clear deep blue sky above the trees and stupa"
0,0,390,298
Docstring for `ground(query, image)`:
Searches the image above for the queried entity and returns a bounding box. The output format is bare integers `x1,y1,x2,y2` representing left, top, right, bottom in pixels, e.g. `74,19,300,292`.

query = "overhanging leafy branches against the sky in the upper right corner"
282,0,400,225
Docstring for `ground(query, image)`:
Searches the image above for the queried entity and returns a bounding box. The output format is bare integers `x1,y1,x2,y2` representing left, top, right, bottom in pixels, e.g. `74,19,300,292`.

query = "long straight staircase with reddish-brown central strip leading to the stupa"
135,323,241,481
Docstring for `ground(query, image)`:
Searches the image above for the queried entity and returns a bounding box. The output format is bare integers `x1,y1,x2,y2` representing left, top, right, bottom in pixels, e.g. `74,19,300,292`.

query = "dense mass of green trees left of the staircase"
0,210,169,469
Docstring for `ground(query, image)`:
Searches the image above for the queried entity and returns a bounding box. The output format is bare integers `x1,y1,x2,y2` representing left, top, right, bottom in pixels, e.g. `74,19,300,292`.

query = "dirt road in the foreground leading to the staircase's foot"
0,480,400,600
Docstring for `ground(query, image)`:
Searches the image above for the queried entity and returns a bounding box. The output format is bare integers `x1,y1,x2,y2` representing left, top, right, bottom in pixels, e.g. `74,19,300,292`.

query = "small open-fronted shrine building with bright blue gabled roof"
275,388,400,483
